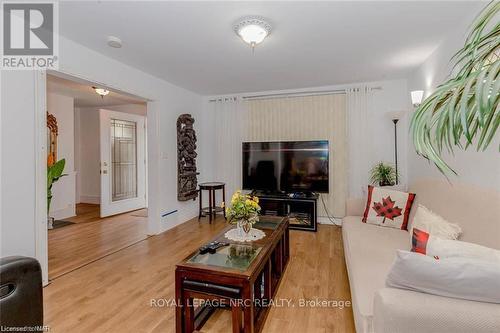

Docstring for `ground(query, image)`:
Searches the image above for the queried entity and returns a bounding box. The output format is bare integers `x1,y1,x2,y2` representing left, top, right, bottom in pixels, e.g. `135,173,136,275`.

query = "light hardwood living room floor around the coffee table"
44,214,354,333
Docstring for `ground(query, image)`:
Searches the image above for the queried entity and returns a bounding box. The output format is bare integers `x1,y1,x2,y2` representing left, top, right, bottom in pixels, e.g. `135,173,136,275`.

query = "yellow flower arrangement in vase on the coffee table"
222,190,260,236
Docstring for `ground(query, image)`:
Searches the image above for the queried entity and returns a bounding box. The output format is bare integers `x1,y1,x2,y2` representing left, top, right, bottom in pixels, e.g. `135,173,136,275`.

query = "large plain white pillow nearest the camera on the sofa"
386,250,500,303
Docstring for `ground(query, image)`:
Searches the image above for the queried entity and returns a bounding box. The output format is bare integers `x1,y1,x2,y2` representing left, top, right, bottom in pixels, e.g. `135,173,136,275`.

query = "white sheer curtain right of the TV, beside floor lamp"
346,86,374,198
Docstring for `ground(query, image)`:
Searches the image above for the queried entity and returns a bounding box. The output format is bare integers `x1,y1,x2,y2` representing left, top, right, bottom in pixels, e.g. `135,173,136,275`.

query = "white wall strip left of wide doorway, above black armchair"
0,71,36,257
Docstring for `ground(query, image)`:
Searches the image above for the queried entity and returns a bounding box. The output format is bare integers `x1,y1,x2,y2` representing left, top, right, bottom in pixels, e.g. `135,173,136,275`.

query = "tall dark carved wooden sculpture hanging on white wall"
177,114,199,201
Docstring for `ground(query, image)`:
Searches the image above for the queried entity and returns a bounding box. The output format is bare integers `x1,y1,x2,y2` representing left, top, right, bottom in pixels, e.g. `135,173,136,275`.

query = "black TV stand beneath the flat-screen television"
252,191,319,231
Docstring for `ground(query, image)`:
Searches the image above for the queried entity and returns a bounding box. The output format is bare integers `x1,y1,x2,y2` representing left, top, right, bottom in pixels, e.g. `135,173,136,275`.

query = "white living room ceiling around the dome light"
60,1,485,95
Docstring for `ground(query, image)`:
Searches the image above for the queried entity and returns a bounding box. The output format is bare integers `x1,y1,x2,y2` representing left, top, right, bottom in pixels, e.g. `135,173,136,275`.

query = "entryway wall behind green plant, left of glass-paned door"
47,93,76,220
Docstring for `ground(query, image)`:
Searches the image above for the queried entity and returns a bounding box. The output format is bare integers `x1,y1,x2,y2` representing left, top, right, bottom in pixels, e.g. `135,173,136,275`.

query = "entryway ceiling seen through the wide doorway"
47,75,145,107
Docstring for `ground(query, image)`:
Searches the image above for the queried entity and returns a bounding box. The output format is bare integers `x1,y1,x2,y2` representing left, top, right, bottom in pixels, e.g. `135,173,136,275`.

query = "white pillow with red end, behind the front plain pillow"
411,228,500,265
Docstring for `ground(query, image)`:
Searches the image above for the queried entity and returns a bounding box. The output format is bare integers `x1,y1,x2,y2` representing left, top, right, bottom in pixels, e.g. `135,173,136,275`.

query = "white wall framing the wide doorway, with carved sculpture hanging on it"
1,36,209,276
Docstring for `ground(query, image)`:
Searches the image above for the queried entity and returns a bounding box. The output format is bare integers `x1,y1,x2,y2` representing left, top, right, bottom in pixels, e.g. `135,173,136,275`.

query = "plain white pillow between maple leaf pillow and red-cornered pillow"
410,205,462,242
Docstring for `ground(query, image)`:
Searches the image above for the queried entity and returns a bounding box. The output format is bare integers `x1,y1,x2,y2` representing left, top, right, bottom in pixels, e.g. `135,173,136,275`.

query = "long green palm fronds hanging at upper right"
410,1,500,175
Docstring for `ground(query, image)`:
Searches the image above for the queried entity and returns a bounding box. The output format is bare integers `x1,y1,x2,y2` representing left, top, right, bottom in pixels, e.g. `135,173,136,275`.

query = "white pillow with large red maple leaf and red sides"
363,185,415,230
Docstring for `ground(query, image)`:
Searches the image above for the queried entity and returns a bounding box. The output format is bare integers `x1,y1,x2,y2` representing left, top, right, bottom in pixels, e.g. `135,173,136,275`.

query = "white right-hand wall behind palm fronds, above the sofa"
407,13,500,191
